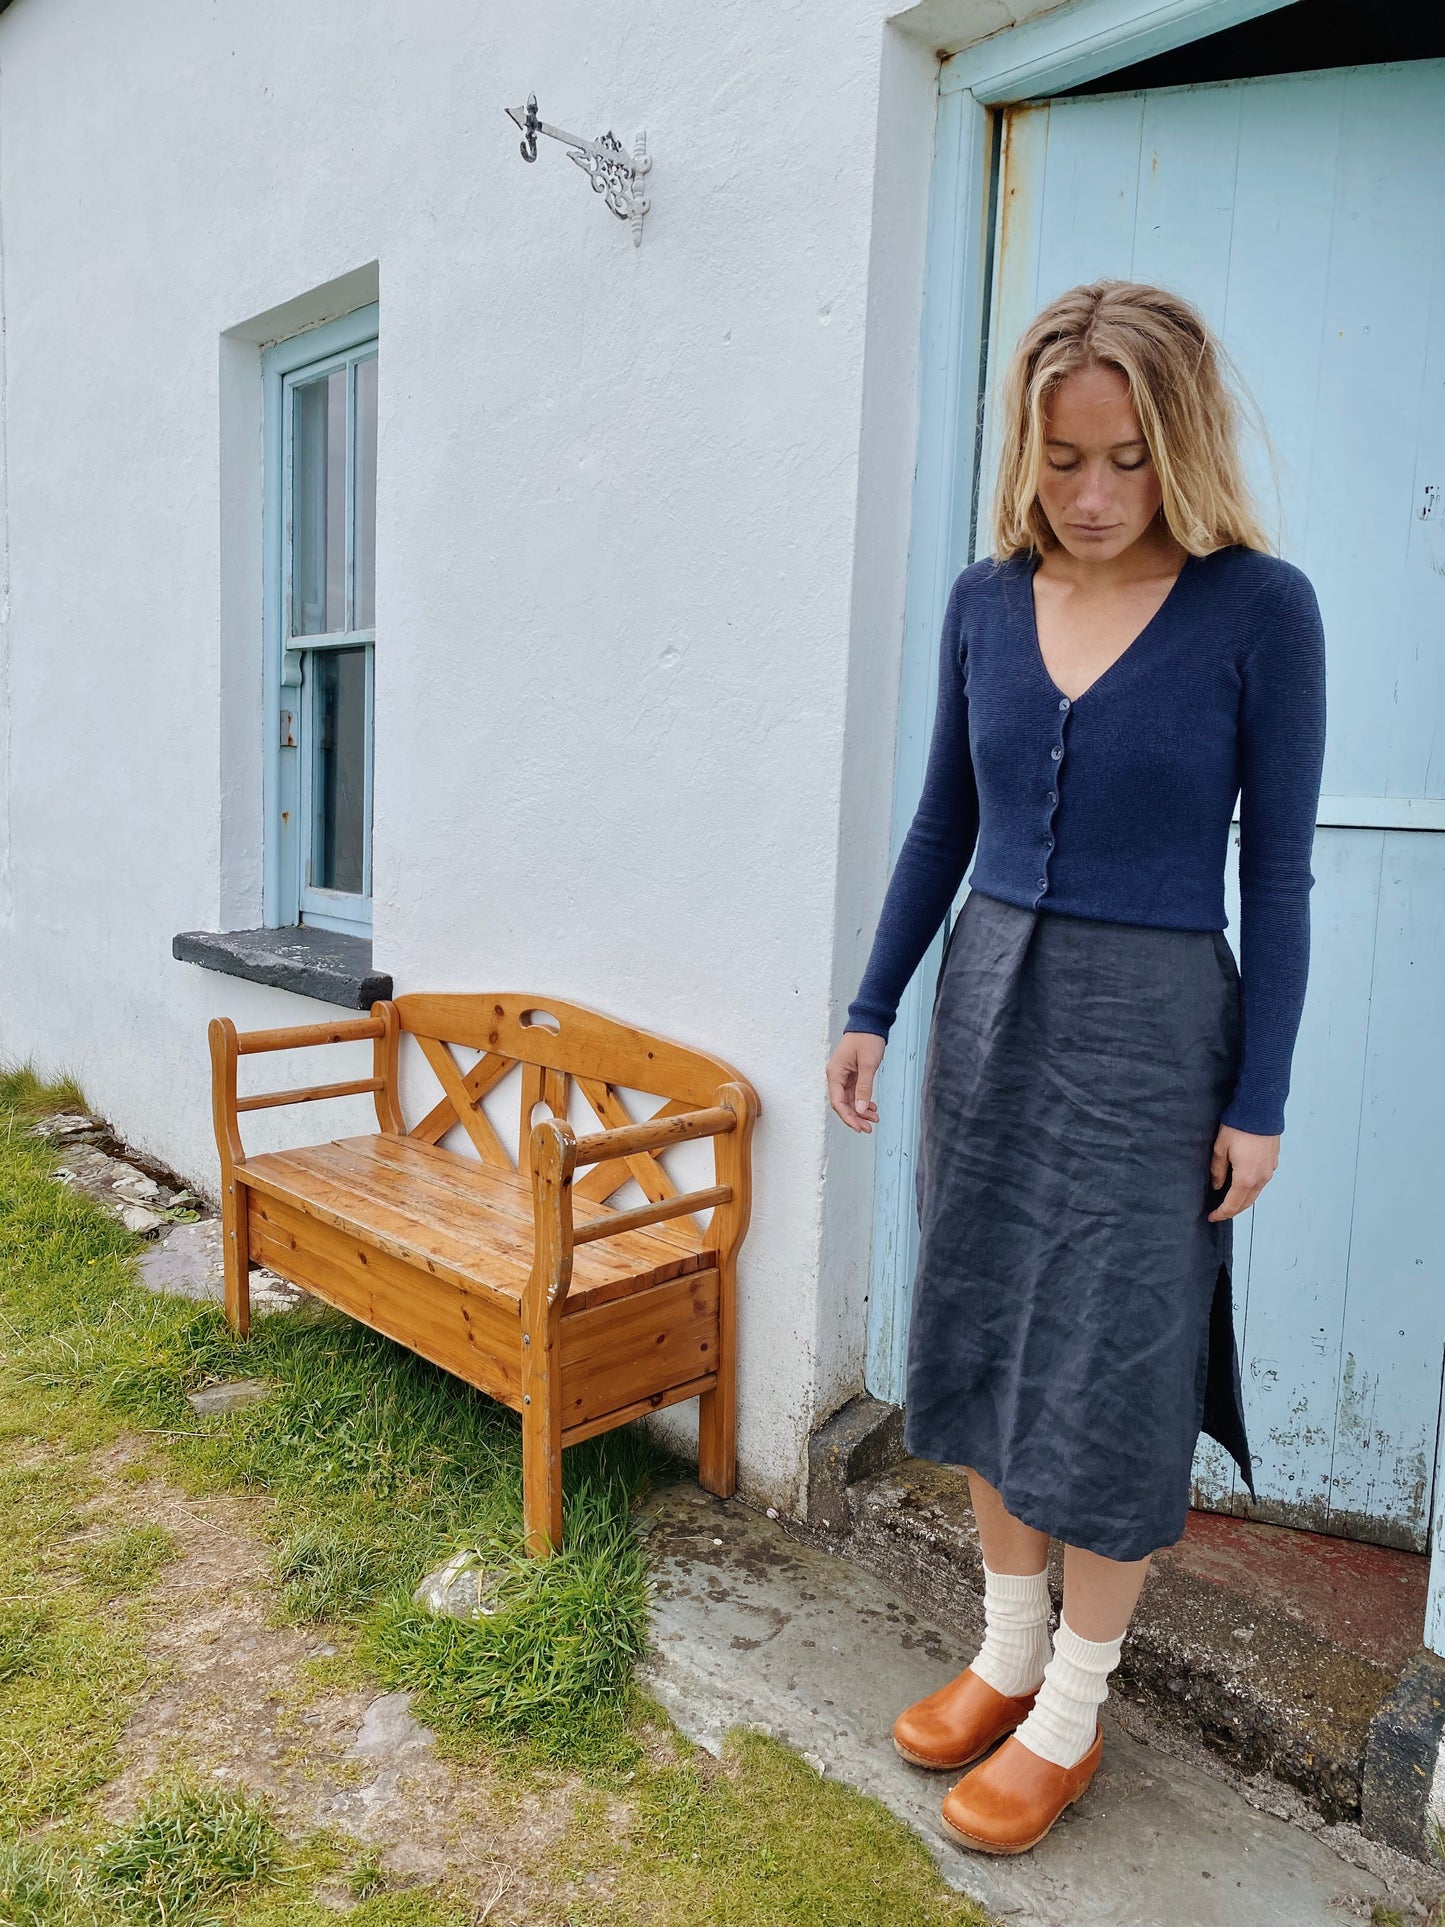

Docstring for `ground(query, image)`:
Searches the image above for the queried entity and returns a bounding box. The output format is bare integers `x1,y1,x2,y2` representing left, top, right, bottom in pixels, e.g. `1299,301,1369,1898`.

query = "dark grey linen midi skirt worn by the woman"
906,892,1254,1559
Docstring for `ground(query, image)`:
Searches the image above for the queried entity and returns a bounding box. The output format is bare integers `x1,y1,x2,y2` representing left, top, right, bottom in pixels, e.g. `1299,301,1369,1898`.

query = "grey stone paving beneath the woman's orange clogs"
645,1486,1410,1927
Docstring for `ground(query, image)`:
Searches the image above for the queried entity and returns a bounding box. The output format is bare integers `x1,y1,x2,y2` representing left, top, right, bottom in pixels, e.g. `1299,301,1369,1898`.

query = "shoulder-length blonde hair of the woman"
992,281,1274,561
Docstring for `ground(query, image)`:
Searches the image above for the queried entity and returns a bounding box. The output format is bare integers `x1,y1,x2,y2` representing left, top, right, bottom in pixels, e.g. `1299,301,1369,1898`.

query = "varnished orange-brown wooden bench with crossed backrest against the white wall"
210,992,757,1555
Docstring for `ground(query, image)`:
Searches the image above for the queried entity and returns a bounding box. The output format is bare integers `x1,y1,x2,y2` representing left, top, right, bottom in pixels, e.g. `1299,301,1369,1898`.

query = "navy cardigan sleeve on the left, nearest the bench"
848,572,979,1037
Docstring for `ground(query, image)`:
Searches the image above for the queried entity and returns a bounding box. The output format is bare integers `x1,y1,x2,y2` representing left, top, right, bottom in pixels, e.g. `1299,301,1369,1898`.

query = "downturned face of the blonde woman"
1038,362,1162,563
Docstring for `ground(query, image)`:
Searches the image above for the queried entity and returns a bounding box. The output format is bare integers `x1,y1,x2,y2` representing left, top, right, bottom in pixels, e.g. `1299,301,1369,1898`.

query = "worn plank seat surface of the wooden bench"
237,1137,711,1314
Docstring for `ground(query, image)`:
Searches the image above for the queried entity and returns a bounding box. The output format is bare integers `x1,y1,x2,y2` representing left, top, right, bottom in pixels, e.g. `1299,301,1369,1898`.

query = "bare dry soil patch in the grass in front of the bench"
87,1438,593,1923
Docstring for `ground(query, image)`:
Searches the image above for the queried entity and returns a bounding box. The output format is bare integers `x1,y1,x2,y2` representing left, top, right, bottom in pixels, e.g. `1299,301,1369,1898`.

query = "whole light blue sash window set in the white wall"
262,306,378,935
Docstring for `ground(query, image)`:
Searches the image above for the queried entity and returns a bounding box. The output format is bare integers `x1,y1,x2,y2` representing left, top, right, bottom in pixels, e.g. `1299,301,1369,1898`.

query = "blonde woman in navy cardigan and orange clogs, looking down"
828,281,1324,1854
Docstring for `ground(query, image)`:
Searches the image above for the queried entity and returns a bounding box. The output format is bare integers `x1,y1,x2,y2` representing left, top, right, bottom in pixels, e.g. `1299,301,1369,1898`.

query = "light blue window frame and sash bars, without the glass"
260,303,380,937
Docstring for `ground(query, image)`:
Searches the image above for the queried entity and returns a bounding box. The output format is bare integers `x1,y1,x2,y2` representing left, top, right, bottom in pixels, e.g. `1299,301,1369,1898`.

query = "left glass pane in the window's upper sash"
291,368,347,636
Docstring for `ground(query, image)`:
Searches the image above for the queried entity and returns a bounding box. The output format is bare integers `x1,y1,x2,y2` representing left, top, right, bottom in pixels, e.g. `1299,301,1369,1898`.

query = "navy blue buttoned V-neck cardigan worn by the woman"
848,545,1326,1135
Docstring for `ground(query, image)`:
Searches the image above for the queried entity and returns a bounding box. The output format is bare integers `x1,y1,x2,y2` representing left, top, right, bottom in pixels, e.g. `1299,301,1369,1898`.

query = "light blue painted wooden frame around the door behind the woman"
865,0,1445,1653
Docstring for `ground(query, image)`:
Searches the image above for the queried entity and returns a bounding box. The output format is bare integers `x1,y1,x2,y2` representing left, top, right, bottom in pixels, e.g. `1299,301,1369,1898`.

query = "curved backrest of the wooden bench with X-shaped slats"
391,990,762,1202
